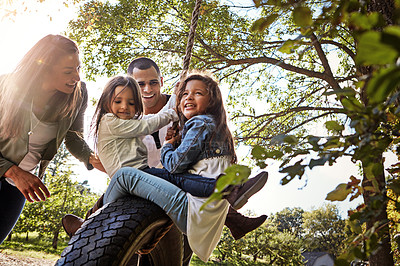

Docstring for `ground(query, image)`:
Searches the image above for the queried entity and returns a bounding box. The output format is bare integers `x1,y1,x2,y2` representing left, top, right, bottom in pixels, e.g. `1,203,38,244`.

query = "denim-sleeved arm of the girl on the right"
161,118,210,173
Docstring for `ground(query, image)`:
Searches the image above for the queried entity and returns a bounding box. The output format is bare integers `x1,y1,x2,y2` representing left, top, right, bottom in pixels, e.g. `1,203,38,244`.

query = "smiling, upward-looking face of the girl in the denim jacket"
179,80,210,119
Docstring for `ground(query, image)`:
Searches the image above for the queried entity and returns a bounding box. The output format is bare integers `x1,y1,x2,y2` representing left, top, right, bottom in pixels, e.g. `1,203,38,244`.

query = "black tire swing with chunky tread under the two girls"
56,197,183,266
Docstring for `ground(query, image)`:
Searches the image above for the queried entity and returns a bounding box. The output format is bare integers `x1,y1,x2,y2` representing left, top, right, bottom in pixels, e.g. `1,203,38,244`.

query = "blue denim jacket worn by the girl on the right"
161,115,232,173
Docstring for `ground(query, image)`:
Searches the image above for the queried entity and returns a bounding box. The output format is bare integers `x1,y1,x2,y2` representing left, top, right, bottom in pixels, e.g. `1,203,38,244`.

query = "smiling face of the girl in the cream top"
111,86,136,120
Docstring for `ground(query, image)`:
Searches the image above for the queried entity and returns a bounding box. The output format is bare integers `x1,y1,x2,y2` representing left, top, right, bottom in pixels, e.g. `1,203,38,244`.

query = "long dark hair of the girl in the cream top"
91,76,143,149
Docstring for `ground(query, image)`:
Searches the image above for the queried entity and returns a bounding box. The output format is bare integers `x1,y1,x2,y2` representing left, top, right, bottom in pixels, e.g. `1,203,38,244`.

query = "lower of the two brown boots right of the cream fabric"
225,207,267,240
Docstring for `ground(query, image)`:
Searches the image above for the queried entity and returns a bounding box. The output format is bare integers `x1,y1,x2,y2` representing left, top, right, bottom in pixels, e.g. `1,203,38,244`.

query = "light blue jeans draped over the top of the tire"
103,167,188,234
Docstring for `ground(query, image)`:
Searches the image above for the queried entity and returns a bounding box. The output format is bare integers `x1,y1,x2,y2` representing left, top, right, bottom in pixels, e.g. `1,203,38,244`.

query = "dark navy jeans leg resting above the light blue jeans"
143,167,217,198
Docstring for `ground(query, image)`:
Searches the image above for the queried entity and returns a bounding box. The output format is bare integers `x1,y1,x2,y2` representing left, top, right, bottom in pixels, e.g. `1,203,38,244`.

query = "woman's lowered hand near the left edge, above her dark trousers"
4,165,50,202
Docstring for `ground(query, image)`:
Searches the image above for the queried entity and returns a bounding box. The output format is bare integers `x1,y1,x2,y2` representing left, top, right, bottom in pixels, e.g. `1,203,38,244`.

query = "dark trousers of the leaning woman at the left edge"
0,178,25,244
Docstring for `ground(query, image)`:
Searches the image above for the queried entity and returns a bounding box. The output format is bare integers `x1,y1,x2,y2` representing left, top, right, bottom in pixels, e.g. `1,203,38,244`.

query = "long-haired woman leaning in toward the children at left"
0,35,102,243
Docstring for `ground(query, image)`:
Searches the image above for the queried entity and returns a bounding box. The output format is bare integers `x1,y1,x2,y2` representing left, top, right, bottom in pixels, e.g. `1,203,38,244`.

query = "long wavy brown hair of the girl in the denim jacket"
176,71,237,163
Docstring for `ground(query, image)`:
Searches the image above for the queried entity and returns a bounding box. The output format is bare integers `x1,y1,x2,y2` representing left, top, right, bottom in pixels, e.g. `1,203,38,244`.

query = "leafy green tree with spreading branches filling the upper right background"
65,0,400,265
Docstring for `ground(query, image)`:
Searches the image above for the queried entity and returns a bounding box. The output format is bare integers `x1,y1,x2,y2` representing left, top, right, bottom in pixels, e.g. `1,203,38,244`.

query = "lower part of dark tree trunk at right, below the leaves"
362,154,394,266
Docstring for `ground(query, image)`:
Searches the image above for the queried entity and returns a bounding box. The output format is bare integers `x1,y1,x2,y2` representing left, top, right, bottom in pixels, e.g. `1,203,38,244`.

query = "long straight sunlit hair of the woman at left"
0,34,82,139
